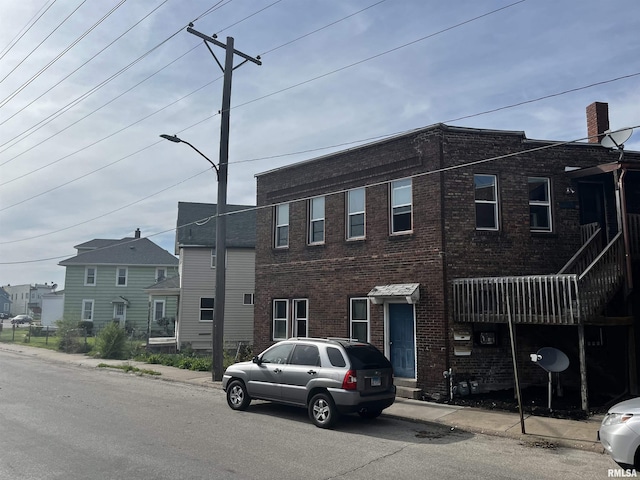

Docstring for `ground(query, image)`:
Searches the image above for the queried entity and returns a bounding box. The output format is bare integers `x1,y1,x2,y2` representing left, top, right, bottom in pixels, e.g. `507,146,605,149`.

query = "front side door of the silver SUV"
247,343,293,401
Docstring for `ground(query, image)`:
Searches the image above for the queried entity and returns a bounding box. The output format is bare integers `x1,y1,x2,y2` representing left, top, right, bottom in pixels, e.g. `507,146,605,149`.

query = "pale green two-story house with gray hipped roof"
59,229,178,333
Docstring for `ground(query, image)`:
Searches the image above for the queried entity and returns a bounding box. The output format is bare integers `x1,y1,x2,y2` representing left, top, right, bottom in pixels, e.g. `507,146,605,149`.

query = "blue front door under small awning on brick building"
389,303,416,378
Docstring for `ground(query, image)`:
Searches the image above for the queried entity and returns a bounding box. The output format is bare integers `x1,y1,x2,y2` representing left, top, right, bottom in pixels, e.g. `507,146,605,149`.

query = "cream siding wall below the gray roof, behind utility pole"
178,248,255,350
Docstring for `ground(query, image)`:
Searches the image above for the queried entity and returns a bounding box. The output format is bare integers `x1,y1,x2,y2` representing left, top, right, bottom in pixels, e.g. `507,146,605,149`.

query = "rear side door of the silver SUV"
282,344,320,405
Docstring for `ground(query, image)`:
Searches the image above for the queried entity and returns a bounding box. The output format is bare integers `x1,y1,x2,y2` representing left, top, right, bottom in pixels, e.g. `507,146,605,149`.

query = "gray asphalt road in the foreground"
0,351,613,480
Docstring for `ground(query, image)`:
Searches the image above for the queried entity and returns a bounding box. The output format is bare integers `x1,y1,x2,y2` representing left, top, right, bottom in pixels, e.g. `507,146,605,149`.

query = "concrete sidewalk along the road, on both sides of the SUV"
0,343,604,453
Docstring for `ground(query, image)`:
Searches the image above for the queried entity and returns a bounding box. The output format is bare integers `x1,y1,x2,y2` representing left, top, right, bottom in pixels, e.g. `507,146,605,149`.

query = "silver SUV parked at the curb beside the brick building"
222,338,396,428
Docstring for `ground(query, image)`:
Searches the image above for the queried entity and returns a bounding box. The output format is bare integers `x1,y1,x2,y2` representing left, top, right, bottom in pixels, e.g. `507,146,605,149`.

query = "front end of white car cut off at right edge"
598,397,640,469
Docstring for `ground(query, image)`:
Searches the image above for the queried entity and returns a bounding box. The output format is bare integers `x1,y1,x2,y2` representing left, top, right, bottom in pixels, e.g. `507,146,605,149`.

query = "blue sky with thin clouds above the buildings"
0,0,640,289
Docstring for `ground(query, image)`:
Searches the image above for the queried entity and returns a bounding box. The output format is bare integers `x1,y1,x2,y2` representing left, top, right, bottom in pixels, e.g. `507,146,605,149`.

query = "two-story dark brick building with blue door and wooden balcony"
254,104,640,408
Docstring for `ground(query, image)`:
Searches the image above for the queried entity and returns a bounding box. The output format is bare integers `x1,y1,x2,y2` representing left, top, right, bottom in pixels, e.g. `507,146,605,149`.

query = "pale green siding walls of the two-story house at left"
64,265,178,333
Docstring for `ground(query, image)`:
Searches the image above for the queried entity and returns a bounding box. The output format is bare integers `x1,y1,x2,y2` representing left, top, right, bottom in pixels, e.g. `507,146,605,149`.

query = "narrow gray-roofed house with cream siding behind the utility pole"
175,202,256,351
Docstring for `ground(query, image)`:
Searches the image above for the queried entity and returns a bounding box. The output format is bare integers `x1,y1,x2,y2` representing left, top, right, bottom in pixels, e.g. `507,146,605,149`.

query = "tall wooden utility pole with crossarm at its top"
187,24,262,381
